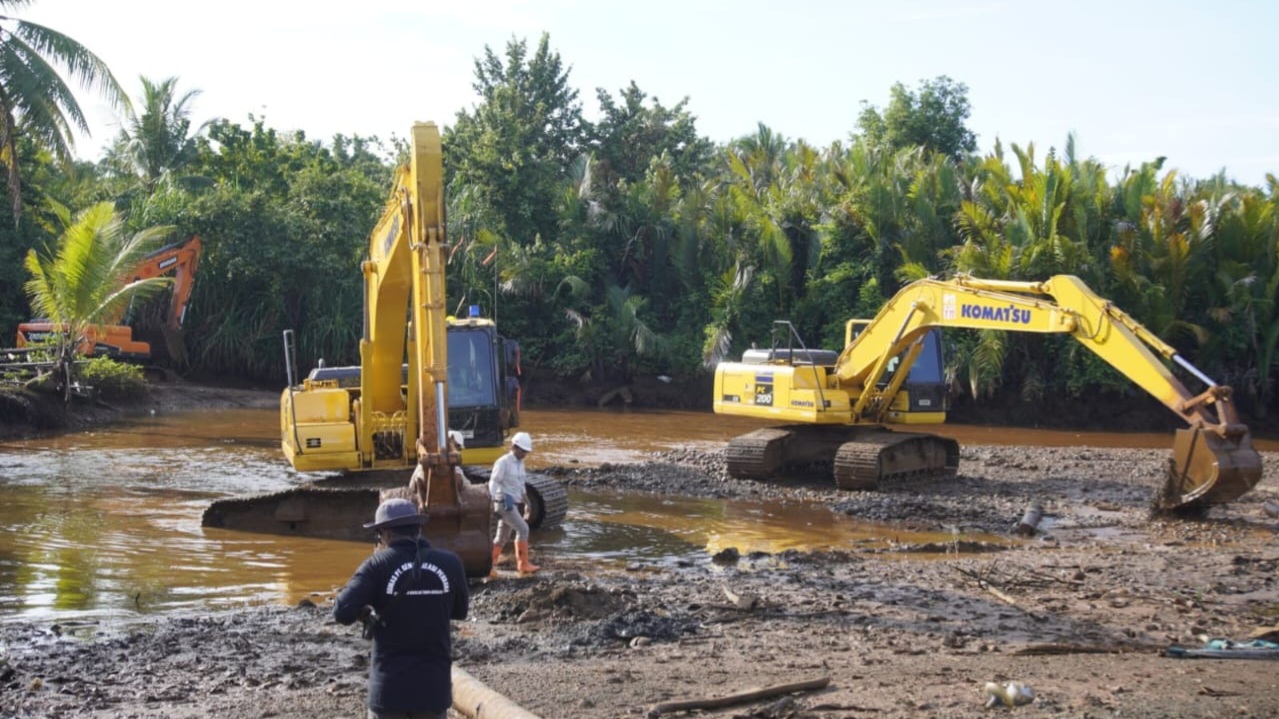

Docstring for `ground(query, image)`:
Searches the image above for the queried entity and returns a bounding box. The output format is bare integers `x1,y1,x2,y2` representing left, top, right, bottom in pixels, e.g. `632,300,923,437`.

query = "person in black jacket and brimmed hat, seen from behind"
333,499,469,719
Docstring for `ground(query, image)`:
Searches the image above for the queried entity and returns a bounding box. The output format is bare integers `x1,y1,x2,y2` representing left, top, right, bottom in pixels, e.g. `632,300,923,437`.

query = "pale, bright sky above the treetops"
13,0,1279,184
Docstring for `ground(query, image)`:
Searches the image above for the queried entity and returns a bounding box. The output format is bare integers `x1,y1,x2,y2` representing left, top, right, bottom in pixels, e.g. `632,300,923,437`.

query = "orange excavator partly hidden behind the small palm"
18,235,203,361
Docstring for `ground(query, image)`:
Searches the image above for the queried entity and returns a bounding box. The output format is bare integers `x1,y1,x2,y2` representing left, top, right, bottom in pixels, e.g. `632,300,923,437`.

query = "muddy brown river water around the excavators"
0,409,1279,620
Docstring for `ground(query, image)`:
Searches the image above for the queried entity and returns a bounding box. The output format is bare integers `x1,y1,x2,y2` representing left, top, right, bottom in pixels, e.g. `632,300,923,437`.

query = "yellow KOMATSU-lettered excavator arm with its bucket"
833,275,1261,507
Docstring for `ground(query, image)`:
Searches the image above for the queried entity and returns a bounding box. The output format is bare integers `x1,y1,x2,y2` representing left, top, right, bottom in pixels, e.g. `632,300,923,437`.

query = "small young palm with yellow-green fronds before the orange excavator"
24,202,173,399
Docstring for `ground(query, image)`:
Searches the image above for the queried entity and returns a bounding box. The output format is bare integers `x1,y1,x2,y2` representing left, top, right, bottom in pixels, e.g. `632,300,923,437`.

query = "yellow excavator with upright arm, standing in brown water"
203,123,568,577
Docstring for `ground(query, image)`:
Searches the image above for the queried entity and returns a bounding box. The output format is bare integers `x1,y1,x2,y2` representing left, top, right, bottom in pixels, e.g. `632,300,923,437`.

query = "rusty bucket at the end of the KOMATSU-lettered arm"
1157,427,1261,510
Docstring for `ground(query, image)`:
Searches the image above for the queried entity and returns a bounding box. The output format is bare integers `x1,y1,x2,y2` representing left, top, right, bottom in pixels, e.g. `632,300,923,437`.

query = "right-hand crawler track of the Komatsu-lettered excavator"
834,430,959,490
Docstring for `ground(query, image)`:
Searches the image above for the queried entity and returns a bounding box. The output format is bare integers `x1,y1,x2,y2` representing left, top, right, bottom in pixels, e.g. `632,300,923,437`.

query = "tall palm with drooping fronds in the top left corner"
0,0,129,219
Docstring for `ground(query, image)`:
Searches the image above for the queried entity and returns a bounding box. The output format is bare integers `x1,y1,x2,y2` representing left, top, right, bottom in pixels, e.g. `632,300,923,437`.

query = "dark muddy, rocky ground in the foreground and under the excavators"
0,429,1279,719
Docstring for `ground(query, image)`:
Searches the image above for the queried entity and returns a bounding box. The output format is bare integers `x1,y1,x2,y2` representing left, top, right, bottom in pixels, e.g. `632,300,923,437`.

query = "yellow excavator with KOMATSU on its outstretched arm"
714,275,1261,509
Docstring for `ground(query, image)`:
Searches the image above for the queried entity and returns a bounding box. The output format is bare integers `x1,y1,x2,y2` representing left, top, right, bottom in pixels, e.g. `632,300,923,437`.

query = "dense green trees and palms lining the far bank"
0,25,1279,415
